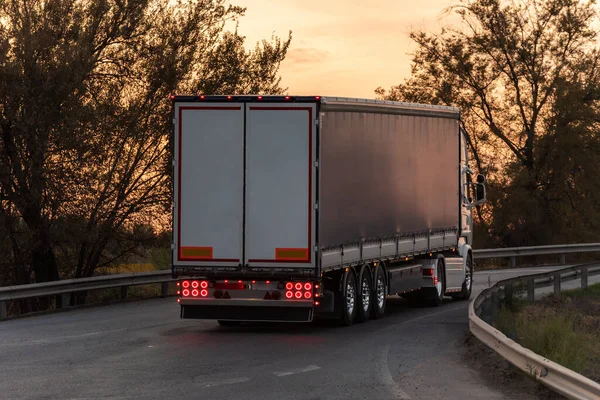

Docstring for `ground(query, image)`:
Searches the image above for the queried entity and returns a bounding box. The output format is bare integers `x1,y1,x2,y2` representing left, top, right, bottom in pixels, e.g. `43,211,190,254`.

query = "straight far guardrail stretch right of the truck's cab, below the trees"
473,243,600,268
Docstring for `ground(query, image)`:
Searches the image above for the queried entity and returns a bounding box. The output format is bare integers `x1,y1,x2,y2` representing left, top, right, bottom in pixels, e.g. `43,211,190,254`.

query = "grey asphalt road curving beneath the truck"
0,268,584,400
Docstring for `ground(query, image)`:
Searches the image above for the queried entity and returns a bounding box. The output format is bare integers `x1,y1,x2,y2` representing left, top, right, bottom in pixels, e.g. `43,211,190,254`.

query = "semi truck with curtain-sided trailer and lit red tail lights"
171,95,485,326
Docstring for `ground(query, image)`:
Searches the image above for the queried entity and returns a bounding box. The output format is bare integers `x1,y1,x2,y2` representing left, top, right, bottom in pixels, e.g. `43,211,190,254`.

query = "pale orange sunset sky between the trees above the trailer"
230,0,458,98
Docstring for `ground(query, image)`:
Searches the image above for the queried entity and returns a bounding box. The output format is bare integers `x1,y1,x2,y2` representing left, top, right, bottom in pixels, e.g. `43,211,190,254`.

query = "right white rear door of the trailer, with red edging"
245,103,316,268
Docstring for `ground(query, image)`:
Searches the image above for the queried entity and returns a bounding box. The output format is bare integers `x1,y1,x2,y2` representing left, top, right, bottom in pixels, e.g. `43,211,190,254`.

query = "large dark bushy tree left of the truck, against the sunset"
0,0,291,290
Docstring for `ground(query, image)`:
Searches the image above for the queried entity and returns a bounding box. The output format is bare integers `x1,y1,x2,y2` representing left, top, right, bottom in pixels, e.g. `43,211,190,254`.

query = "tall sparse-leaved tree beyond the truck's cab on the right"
376,0,599,244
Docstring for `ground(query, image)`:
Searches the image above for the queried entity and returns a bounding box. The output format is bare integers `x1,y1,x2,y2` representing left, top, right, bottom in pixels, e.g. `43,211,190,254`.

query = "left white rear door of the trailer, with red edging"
173,103,244,266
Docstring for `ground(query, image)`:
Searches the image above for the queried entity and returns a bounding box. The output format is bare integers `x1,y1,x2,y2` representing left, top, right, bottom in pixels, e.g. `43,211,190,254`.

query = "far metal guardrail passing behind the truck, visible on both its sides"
0,243,600,320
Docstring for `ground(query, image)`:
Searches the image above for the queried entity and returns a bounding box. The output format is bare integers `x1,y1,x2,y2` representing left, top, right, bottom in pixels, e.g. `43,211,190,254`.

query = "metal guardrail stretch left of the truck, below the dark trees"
0,270,175,320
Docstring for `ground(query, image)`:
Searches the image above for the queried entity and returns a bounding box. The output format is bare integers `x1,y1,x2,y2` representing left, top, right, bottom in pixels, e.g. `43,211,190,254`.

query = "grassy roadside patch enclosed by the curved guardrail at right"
494,284,600,382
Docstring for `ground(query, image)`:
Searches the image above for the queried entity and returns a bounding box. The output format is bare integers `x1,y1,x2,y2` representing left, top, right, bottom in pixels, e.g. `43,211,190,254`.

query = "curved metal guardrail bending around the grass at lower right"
469,263,600,400
